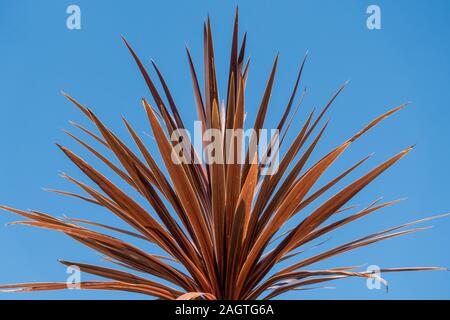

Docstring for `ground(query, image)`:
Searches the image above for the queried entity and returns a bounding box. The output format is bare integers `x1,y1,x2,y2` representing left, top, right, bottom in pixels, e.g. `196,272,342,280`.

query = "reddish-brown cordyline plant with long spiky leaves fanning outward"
0,12,441,299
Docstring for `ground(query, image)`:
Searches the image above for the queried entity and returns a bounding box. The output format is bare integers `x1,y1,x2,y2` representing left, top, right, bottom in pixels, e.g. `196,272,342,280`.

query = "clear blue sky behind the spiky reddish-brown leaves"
0,0,450,299
